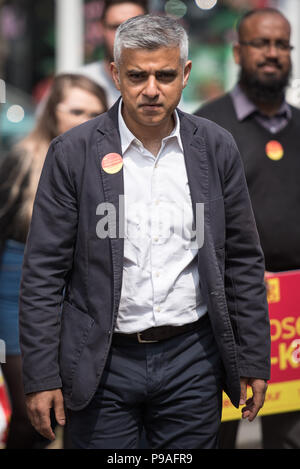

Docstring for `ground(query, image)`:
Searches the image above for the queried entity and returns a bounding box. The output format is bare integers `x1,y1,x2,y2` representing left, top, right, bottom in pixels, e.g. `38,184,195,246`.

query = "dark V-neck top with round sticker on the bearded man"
196,90,300,272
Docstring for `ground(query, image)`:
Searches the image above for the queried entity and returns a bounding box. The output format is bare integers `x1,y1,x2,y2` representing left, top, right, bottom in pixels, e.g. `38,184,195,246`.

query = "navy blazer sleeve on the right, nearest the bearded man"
224,139,271,379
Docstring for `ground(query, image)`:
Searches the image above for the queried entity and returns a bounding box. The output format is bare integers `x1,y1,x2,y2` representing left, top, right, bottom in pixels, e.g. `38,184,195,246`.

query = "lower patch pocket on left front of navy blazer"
59,301,94,394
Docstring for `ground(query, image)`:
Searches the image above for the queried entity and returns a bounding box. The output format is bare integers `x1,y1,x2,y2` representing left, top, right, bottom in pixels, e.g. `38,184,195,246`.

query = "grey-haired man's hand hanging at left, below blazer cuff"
26,389,66,440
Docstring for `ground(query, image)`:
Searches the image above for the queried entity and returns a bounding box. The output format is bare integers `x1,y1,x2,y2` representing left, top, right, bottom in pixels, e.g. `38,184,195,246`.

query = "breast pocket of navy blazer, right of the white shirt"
209,197,226,249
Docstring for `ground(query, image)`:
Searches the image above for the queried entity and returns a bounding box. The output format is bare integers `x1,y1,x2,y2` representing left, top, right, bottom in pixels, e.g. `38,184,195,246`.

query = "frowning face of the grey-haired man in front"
112,47,191,133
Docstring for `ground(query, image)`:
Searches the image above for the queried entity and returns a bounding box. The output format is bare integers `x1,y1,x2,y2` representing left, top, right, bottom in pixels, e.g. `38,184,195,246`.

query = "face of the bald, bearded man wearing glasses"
234,13,291,85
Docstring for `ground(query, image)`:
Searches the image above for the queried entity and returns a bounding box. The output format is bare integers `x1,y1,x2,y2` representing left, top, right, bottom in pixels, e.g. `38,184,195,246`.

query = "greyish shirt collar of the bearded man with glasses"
230,83,291,121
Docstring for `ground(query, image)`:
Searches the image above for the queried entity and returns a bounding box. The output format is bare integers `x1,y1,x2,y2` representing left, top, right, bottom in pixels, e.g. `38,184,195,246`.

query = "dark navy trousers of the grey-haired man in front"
68,318,223,449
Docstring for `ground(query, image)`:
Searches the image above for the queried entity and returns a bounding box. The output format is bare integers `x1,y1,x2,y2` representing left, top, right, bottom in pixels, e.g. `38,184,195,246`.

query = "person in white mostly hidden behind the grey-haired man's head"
79,0,148,107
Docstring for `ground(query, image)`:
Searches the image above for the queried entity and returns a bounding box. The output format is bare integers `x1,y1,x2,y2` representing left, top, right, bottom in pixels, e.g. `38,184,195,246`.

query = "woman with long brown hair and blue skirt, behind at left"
0,74,107,449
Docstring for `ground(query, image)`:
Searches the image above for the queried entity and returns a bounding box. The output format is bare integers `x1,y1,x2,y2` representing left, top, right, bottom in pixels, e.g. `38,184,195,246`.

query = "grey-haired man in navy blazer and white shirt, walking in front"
20,15,270,449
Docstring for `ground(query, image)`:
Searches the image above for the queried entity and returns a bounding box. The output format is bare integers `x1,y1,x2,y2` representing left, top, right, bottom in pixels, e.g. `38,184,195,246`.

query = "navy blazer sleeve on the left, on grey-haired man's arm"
19,139,77,393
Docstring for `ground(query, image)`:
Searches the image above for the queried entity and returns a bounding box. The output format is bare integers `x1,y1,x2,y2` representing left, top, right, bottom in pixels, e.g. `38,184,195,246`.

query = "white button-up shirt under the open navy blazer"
115,101,207,333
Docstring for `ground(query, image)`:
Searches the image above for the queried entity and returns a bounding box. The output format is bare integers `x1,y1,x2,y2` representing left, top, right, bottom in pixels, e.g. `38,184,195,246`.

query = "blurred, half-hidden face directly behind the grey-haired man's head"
103,1,145,62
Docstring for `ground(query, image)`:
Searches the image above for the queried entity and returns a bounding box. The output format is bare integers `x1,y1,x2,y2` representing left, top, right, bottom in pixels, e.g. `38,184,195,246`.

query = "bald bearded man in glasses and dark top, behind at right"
196,8,300,449
